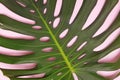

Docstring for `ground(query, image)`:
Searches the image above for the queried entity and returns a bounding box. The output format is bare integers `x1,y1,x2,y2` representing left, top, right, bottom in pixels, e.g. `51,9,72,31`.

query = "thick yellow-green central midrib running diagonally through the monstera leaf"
32,2,74,73
